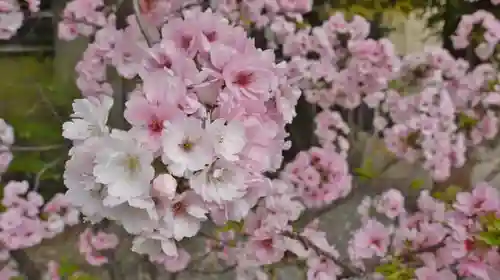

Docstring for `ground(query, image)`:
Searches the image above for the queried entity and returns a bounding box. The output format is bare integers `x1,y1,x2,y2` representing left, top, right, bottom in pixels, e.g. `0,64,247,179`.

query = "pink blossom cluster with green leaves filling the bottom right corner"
349,182,500,280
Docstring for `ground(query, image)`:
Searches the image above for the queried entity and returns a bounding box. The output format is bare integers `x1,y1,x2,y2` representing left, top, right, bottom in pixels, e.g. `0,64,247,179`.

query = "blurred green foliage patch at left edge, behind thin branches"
0,56,76,197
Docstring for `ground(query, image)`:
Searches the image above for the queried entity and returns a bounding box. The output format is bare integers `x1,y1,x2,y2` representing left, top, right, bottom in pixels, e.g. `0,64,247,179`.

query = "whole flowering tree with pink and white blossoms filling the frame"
0,0,500,280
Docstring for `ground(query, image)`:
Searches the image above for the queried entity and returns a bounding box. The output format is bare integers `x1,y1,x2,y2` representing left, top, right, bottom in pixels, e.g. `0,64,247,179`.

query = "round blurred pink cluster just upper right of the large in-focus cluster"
283,13,399,109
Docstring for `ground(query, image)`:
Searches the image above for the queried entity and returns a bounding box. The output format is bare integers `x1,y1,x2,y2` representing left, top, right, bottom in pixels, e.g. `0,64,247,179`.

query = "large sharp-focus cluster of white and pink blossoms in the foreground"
63,7,300,262
